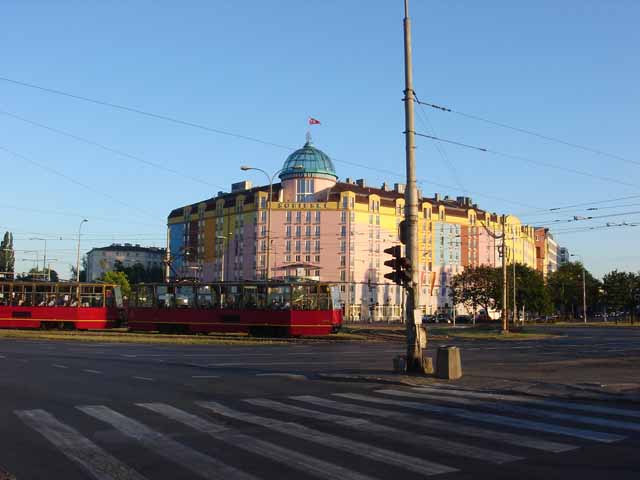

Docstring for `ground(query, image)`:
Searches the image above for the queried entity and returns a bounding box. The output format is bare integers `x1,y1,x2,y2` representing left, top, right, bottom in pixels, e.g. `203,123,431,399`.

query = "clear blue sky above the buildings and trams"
0,0,640,277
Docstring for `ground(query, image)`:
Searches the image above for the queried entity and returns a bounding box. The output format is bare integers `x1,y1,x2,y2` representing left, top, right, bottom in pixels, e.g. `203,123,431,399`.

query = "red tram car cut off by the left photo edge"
0,281,122,330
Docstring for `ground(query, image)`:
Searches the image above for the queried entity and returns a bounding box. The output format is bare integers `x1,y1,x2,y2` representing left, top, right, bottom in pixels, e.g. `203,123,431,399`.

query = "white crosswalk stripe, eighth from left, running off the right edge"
377,390,640,432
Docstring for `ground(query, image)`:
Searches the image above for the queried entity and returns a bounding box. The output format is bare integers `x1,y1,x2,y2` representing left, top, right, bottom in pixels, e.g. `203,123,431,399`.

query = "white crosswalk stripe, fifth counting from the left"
245,398,522,464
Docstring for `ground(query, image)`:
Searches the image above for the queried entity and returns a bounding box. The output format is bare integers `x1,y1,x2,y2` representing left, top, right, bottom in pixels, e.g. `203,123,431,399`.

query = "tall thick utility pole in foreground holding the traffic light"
403,0,422,372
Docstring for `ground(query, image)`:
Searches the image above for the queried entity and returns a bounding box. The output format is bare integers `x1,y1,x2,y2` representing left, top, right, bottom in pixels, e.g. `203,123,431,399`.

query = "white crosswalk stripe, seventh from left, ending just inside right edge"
333,393,627,443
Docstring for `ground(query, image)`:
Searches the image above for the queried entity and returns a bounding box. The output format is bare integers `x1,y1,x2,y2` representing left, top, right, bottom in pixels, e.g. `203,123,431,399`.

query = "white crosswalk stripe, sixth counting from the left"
290,395,578,453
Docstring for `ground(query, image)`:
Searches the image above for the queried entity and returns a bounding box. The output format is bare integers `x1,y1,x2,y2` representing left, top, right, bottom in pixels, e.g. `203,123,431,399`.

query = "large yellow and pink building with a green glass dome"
168,137,537,321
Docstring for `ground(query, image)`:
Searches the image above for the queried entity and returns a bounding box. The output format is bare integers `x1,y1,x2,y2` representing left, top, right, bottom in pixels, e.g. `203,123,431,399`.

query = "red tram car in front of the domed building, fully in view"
127,282,342,336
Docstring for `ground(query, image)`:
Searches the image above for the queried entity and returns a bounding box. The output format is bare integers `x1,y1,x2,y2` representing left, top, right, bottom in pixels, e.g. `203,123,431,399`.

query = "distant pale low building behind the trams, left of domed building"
87,243,166,282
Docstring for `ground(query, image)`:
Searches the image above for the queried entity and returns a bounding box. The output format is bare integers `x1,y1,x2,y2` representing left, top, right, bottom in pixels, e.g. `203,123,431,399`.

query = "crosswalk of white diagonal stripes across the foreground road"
10,386,640,480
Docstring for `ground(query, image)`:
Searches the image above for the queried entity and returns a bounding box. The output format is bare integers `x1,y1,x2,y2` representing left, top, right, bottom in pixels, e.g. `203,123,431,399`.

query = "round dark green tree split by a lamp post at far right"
547,262,602,318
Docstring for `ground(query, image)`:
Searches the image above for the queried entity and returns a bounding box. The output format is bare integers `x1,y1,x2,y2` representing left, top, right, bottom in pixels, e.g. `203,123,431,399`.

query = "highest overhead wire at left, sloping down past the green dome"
0,76,536,212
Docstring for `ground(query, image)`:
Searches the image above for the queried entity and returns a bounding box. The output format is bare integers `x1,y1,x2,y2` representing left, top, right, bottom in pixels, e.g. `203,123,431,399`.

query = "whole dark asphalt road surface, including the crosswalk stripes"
0,329,640,480
